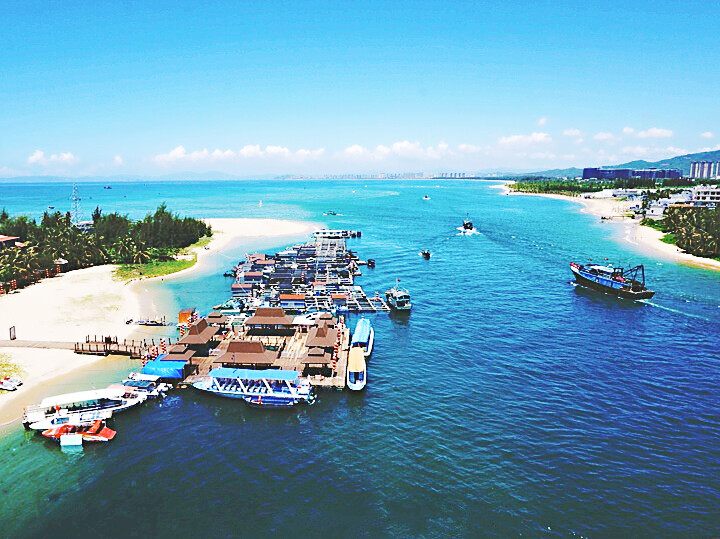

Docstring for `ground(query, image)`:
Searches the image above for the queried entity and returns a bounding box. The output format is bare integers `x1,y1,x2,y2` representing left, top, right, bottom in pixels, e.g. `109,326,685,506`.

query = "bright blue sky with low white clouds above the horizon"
0,0,720,177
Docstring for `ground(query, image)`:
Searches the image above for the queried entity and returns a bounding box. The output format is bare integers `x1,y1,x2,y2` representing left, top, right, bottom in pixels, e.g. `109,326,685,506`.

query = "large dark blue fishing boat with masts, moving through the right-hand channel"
570,262,655,299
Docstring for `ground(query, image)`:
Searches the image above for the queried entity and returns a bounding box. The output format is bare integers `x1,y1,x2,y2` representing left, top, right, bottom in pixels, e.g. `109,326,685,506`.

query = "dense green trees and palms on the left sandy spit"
0,204,212,291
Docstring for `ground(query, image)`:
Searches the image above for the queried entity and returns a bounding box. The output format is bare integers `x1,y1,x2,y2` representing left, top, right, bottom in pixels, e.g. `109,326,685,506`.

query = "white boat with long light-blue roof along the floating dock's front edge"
193,367,317,408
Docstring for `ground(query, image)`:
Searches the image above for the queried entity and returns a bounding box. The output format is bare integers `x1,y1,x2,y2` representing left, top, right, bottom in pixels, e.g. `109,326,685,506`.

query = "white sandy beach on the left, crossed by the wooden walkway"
0,219,315,416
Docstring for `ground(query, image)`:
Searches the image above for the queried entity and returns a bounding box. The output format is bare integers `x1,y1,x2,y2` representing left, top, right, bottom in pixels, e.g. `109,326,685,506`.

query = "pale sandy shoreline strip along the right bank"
492,184,720,271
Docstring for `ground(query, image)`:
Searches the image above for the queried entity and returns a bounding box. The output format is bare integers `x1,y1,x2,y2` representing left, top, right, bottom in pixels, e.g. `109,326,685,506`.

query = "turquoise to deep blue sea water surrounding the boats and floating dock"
0,180,720,537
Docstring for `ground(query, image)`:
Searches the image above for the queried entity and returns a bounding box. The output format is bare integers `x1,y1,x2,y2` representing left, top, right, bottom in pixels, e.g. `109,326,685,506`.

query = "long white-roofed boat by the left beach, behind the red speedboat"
23,386,147,430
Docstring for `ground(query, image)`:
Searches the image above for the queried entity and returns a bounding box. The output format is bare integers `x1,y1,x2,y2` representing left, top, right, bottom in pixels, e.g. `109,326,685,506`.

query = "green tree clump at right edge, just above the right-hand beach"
641,206,720,258
